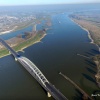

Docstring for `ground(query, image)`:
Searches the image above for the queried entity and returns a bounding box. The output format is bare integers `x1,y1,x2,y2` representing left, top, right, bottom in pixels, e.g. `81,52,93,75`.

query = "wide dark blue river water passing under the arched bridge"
0,14,99,100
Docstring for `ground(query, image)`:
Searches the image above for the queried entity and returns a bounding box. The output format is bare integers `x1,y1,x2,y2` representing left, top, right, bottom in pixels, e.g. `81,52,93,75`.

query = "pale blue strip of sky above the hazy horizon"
0,0,100,6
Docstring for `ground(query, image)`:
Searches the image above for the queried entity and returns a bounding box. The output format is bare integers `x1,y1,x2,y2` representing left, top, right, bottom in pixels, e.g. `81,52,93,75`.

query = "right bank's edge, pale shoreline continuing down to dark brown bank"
71,15,100,87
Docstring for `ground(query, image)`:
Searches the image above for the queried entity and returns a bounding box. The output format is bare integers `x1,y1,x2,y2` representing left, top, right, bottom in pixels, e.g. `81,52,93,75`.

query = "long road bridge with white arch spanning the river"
0,38,68,100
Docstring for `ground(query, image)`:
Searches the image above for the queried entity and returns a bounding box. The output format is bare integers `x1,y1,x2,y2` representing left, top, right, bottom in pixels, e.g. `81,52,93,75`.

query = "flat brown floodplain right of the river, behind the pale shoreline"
69,11,100,46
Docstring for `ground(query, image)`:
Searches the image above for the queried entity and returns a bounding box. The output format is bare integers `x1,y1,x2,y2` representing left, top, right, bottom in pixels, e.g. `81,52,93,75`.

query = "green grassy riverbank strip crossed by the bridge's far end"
0,31,46,58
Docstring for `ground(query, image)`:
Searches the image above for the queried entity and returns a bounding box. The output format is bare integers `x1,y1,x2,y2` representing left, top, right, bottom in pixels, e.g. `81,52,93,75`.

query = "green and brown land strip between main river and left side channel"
0,18,51,57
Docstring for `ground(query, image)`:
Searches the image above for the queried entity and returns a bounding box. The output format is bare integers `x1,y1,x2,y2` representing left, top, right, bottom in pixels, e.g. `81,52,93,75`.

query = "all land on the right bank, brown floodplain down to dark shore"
69,11,100,87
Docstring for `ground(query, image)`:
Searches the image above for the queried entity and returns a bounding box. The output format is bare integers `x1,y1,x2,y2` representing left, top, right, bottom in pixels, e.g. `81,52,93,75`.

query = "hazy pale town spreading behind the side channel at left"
0,9,49,34
